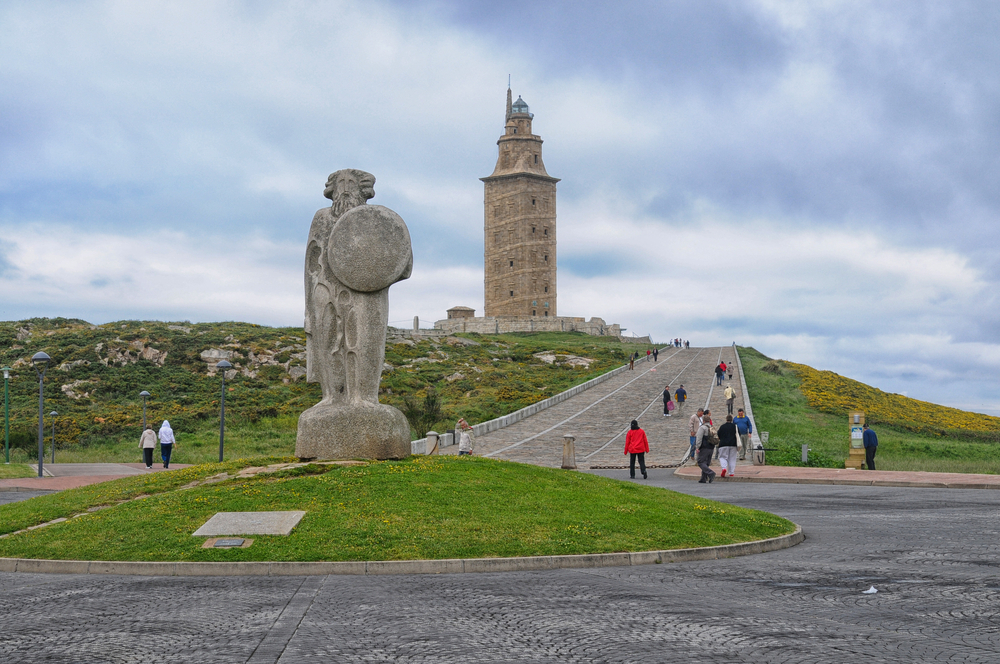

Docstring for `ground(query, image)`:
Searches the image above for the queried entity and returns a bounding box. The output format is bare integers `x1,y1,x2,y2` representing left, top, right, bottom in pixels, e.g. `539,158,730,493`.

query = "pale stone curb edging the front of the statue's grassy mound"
0,525,805,576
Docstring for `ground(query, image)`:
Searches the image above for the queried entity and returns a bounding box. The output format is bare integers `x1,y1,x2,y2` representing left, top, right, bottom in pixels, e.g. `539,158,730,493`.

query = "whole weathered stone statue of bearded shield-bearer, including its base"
295,169,413,459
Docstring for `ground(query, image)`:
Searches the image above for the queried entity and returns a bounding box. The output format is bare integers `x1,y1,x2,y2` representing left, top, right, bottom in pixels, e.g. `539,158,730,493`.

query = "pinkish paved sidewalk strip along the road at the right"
674,465,1000,489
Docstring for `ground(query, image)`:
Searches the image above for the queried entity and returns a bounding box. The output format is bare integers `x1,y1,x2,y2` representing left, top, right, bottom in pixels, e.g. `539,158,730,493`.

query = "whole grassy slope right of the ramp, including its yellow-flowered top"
740,348,1000,473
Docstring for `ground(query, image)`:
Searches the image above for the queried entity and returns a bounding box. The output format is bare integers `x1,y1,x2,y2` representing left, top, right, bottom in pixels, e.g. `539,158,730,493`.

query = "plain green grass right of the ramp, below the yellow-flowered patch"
739,348,1000,474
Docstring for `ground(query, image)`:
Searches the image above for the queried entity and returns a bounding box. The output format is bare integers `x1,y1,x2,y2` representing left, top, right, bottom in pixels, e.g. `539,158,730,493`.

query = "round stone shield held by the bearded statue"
327,205,413,293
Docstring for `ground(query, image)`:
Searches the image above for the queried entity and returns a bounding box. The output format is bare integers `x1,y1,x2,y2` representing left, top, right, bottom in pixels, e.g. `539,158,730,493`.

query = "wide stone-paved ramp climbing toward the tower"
476,346,743,469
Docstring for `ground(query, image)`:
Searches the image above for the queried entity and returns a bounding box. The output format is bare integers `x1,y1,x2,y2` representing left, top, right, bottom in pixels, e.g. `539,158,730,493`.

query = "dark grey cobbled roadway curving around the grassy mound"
0,470,1000,664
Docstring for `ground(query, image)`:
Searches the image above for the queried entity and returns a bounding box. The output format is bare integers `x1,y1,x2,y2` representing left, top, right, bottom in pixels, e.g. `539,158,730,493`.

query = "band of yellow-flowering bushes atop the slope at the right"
783,362,1000,434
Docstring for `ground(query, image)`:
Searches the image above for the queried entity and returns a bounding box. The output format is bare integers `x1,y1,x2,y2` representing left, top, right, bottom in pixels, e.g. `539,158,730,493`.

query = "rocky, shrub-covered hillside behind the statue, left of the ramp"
0,318,637,463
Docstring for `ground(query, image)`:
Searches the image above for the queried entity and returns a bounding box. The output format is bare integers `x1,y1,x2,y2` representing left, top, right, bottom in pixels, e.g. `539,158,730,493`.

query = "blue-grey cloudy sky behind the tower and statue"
0,0,1000,414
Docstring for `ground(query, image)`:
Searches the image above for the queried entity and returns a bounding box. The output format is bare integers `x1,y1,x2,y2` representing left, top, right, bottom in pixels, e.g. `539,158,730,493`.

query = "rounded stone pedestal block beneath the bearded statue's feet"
295,401,410,459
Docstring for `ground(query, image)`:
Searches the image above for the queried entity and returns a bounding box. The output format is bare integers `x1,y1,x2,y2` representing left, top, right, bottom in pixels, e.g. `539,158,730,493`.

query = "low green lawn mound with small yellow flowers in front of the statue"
0,456,794,561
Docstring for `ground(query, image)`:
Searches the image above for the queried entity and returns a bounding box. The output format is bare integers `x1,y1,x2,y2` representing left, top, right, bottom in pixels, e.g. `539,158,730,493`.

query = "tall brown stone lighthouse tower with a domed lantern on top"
480,88,559,317
